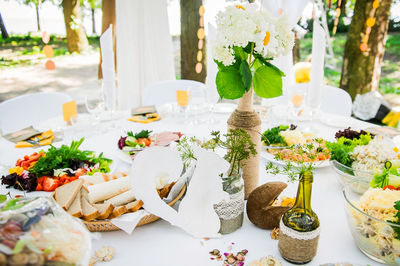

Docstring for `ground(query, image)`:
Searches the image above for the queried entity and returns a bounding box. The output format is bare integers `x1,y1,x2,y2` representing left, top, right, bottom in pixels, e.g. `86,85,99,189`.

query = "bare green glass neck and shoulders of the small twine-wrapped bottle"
282,172,319,232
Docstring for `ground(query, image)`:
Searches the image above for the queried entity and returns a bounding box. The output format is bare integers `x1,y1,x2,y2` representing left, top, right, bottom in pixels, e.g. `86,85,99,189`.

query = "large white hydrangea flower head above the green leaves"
213,3,294,66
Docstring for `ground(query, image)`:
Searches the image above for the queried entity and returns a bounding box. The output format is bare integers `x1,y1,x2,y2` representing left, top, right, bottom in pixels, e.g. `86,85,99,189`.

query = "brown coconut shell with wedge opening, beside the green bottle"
246,182,291,229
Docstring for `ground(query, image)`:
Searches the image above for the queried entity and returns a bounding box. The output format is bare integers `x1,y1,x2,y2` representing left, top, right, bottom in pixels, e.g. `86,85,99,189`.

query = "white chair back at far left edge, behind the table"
0,92,72,134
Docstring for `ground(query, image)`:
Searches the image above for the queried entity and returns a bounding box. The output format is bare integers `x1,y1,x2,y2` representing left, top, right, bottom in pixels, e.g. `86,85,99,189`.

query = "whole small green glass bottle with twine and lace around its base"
278,172,320,264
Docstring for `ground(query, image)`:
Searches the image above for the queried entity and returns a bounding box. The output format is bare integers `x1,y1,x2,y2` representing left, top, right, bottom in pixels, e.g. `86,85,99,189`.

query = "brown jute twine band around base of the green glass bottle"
278,220,319,264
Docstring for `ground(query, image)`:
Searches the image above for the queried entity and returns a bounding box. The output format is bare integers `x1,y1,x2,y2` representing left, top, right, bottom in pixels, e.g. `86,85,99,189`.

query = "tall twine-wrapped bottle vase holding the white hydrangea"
228,89,261,199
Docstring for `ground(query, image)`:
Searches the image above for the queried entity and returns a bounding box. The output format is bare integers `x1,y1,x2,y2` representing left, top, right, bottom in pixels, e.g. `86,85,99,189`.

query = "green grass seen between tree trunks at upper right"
300,33,400,94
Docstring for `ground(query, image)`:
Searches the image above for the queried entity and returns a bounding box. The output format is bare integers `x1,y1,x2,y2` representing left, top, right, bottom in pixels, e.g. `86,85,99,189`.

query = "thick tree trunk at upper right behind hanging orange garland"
340,0,393,99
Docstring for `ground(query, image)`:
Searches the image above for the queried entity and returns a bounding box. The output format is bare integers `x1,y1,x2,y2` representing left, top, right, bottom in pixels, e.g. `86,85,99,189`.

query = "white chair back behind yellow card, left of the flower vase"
142,79,206,106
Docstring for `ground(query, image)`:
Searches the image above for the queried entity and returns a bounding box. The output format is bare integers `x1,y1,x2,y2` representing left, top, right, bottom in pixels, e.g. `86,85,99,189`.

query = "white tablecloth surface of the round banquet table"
0,106,378,266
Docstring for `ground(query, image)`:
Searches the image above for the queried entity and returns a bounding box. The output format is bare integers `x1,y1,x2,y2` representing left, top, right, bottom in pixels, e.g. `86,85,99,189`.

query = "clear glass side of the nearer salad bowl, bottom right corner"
343,181,400,265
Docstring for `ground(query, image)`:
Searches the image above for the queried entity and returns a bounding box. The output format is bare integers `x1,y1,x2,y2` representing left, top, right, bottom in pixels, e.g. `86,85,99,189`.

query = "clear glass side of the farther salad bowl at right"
330,160,374,194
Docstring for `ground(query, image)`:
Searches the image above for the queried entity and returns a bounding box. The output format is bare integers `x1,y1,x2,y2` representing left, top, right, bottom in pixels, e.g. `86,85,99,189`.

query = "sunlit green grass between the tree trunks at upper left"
0,35,99,69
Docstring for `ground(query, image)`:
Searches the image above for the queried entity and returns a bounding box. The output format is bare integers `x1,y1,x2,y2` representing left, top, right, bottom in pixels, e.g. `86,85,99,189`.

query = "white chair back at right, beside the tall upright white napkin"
321,85,353,117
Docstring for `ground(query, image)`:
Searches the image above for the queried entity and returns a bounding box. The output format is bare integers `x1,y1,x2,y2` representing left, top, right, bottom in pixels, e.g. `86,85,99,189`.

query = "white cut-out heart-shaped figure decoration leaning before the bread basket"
128,147,229,238
